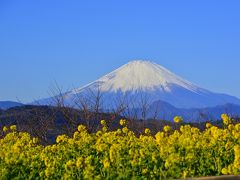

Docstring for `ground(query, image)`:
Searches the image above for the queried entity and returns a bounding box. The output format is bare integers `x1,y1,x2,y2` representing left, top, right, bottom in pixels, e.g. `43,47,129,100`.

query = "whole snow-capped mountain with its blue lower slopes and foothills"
34,61,240,119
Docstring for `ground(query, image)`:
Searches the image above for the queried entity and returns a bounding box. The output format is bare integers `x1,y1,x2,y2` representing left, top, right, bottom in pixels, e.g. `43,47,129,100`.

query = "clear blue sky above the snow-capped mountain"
0,0,240,102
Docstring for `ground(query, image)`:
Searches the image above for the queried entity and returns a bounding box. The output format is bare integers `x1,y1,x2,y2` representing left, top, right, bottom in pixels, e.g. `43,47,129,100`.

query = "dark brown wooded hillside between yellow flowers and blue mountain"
0,106,240,144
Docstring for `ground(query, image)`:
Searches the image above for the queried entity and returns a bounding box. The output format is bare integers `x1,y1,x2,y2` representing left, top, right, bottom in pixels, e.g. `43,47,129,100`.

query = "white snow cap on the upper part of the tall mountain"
74,60,198,92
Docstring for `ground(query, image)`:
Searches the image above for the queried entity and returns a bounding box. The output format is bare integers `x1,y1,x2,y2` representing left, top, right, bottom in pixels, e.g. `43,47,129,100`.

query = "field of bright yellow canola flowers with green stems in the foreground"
0,114,240,179
